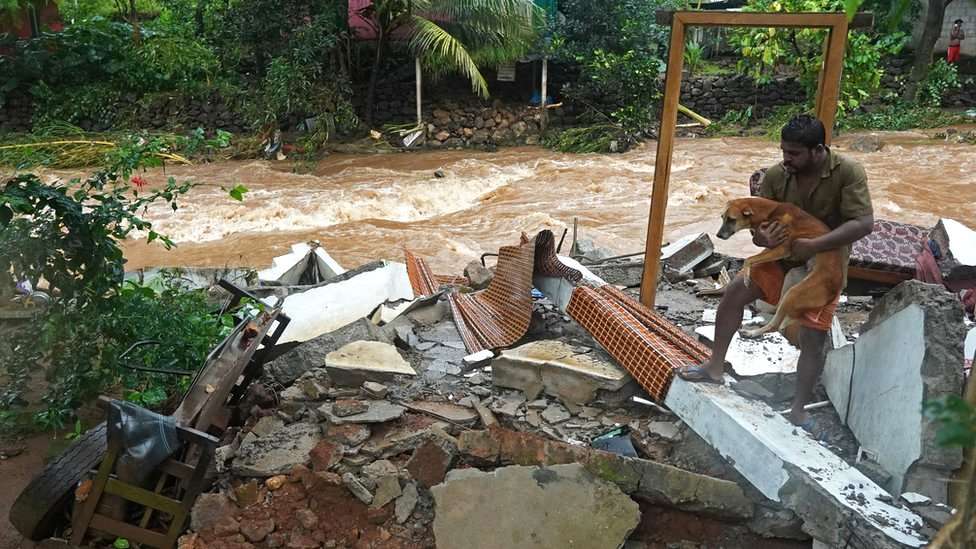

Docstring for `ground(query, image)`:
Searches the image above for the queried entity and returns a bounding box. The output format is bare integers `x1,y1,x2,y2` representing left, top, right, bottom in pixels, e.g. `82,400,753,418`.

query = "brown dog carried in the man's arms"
717,198,844,340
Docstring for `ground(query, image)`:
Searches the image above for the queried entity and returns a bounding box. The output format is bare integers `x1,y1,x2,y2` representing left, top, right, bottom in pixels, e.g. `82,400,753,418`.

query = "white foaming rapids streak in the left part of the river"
132,160,535,242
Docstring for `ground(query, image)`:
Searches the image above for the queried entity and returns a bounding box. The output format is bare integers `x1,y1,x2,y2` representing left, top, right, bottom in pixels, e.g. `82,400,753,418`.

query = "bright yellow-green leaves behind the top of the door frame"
731,0,908,113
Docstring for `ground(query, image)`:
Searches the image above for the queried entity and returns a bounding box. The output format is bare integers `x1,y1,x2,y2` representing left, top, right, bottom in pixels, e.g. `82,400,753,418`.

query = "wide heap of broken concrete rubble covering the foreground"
166,234,964,549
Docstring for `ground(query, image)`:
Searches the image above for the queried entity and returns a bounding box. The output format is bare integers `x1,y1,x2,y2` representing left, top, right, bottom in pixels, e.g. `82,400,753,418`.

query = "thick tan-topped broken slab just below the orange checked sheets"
491,340,632,404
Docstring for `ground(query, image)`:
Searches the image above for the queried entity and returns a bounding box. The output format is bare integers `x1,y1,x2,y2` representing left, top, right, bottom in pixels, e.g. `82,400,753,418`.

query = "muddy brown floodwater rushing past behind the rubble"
103,132,976,271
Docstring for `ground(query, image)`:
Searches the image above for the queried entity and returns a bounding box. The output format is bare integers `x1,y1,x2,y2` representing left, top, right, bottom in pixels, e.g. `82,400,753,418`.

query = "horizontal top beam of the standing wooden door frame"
655,10,874,29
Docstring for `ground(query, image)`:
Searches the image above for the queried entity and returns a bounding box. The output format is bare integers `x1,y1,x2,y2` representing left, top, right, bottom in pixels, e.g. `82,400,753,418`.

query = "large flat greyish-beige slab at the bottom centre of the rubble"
431,464,640,549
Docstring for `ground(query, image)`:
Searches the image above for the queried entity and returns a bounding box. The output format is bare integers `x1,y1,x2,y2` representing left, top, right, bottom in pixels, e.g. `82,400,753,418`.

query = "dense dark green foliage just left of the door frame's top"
555,0,672,132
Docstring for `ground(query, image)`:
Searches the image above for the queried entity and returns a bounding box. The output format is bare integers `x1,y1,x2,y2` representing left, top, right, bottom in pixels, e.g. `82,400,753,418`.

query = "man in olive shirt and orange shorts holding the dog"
678,115,874,432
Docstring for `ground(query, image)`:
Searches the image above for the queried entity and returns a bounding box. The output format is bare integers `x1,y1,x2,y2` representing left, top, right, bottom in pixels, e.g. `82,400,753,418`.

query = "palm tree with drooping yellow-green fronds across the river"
359,0,542,124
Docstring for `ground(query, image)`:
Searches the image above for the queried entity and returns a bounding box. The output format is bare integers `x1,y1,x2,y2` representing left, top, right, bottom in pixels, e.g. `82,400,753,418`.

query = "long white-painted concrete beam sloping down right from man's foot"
665,378,926,548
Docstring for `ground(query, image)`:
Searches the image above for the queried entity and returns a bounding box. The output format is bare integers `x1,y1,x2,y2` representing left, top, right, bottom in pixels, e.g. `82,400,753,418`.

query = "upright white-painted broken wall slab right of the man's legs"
823,281,965,502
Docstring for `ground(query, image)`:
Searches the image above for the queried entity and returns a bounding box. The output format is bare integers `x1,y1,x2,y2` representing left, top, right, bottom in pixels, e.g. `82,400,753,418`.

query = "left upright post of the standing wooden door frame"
641,13,685,307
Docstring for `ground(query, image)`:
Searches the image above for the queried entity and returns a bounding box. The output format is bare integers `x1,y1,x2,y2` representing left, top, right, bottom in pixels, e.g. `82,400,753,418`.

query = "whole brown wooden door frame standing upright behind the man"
640,11,874,307
